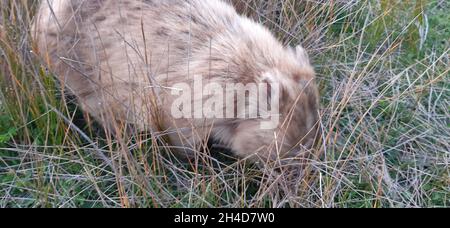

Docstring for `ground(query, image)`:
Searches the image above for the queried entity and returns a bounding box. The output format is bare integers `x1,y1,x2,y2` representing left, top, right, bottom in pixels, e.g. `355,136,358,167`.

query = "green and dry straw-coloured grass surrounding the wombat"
0,0,450,208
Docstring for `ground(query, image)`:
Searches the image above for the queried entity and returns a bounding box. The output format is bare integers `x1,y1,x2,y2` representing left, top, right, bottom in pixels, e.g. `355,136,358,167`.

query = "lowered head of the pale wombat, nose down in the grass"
232,47,320,165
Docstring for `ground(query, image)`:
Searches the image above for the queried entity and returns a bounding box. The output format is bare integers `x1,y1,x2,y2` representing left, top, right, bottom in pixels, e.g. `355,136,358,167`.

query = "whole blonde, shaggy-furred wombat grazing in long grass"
32,0,319,162
